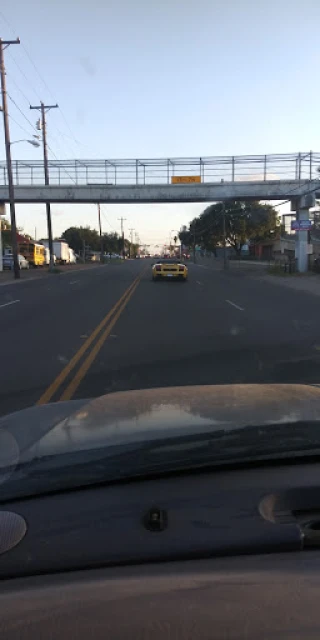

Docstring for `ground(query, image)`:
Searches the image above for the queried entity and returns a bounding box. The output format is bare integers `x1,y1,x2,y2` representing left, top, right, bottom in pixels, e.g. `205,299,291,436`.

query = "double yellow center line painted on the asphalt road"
37,274,142,405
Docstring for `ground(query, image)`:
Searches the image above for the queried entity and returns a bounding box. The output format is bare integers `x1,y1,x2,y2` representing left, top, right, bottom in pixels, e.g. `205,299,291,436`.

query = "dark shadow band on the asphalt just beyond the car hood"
78,344,320,397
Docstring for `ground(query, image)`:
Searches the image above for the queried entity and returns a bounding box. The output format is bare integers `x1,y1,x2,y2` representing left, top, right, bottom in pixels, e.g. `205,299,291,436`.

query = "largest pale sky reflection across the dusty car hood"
53,384,320,444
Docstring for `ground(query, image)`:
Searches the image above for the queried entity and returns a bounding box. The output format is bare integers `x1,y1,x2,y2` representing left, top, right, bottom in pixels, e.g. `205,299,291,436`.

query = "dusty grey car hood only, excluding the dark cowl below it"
0,384,320,459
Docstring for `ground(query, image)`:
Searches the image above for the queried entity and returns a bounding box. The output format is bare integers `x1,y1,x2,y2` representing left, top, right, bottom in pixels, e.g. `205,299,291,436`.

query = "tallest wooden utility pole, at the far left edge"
0,38,20,280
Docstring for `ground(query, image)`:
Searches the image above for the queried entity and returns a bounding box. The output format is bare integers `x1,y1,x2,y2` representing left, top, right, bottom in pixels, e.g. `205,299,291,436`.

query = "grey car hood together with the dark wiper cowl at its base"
0,384,320,498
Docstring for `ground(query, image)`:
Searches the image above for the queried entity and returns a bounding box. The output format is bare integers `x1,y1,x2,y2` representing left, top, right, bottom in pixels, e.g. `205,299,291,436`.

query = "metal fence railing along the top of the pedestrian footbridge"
0,151,320,186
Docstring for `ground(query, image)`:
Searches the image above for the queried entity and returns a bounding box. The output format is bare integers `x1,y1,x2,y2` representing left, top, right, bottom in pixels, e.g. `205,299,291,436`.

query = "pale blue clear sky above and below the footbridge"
0,0,320,244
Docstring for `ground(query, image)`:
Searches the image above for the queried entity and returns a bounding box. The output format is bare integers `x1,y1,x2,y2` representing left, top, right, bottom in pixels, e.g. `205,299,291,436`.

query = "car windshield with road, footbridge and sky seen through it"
0,0,320,499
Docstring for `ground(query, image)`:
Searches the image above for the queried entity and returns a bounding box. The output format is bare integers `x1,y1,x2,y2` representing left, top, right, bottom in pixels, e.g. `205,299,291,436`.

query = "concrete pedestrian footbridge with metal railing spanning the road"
0,151,320,207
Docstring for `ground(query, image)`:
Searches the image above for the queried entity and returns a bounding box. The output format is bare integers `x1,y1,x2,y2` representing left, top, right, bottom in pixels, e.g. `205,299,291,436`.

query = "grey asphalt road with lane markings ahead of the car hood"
0,260,320,415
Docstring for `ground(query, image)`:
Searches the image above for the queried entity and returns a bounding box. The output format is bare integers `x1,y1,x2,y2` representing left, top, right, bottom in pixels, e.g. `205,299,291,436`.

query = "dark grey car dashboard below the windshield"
0,463,320,640
